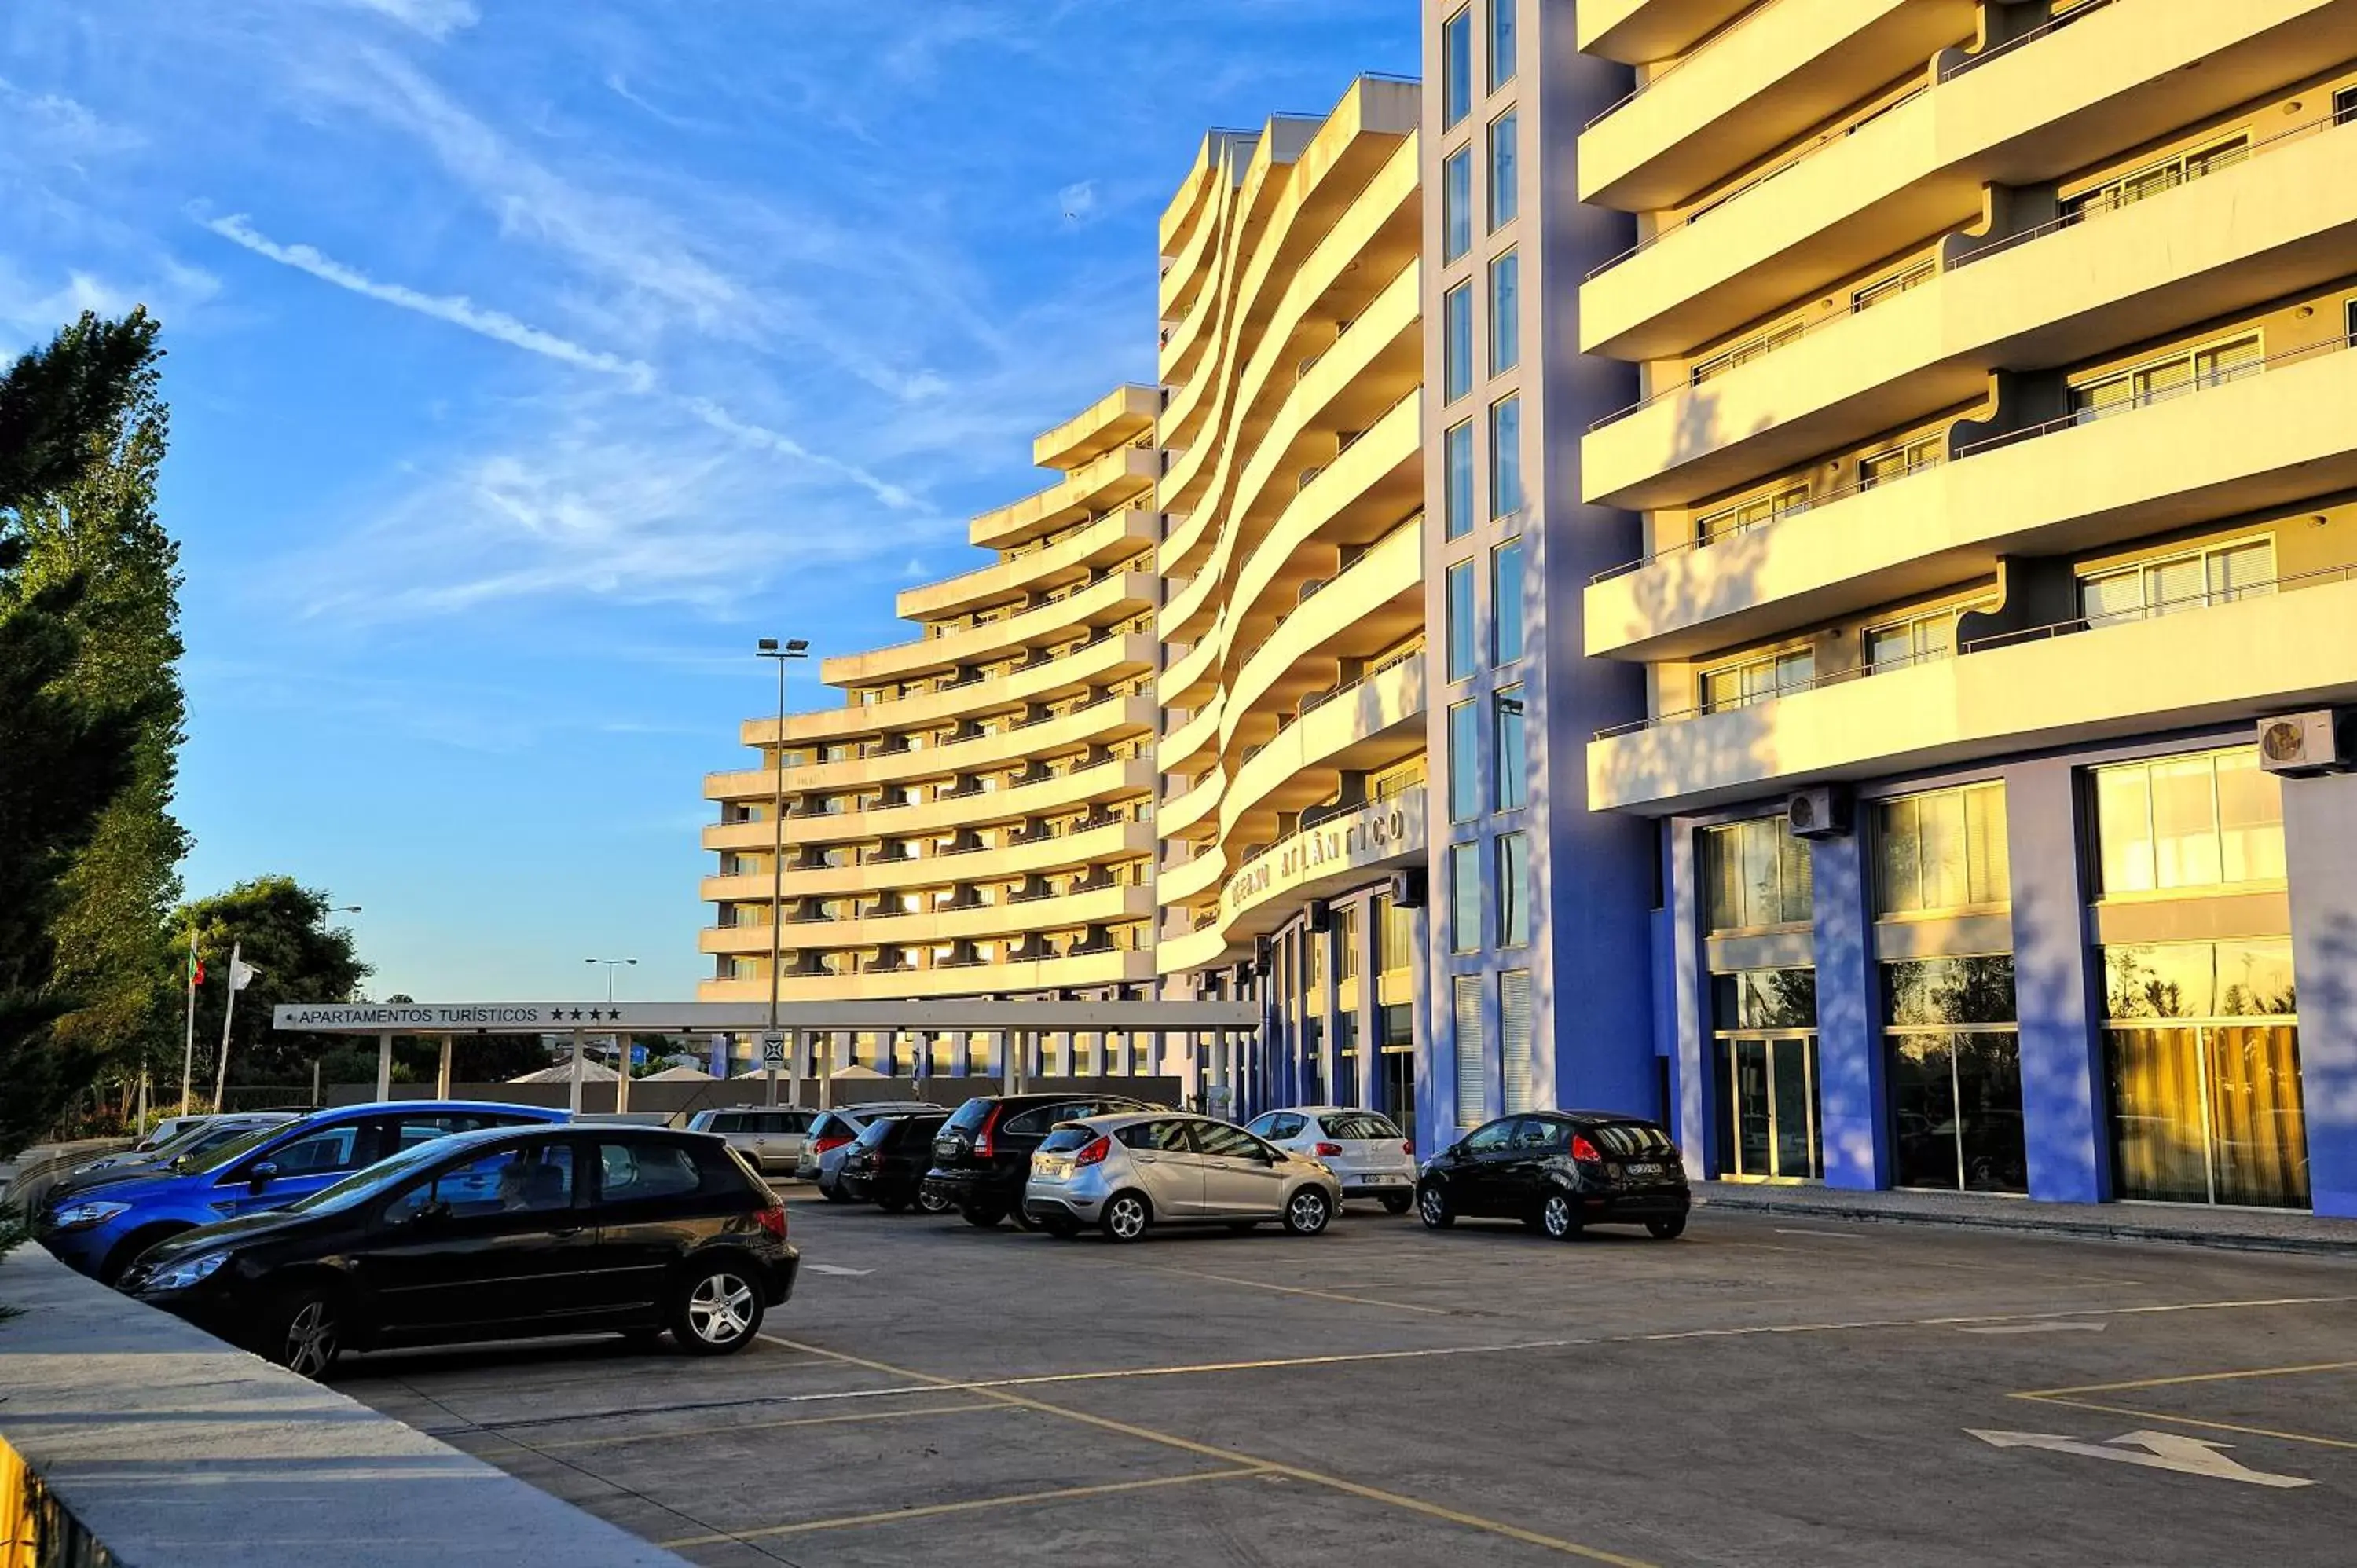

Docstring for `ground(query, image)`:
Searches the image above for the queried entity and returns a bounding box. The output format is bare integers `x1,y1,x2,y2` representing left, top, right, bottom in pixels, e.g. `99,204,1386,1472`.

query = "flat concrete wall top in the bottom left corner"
0,1245,684,1568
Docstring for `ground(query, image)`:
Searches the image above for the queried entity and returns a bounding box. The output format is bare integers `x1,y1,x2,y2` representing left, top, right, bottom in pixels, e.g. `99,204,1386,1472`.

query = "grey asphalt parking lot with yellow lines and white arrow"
337,1191,2357,1568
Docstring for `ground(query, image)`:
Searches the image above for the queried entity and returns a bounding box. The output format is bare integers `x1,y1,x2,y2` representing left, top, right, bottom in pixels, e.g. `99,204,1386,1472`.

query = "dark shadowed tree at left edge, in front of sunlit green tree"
0,311,158,1153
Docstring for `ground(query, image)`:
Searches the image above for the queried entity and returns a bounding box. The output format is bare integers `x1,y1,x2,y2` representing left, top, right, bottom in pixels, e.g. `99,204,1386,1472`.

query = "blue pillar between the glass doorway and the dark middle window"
1808,833,1890,1191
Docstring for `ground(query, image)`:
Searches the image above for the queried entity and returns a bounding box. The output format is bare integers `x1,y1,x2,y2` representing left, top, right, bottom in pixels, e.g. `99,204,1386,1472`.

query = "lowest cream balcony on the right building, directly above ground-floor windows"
1589,568,2357,816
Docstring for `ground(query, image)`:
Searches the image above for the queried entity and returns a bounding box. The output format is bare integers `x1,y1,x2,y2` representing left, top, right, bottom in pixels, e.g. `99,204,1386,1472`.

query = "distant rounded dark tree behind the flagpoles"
172,877,375,1094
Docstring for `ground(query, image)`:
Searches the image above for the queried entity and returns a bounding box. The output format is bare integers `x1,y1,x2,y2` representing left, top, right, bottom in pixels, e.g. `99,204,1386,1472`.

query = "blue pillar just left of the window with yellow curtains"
2006,759,2112,1203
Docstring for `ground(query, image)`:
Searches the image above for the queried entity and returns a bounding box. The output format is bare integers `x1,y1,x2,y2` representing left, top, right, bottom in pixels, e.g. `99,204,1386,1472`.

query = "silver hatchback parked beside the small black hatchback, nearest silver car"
1023,1111,1341,1240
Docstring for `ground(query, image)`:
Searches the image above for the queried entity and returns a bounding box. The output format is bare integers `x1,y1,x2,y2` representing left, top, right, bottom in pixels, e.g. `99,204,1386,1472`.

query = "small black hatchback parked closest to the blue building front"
1417,1111,1692,1240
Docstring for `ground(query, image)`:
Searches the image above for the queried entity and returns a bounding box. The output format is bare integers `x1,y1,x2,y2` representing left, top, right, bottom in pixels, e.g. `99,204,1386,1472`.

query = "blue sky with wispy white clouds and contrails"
0,0,1417,1000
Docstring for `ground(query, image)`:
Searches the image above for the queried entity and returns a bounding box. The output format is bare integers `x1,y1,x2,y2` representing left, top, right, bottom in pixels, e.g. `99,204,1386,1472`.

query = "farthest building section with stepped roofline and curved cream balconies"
700,387,1162,1078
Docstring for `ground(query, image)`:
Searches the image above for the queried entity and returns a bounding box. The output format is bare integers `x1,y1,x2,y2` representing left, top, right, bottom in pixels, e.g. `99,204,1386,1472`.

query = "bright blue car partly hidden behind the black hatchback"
38,1099,568,1285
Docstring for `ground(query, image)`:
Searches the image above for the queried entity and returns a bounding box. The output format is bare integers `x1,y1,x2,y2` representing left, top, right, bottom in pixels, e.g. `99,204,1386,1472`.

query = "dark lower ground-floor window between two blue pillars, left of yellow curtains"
1883,953,2029,1193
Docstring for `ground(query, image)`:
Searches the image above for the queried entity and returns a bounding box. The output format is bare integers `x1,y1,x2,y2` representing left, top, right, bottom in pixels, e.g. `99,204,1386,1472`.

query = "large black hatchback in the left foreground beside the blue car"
120,1125,799,1377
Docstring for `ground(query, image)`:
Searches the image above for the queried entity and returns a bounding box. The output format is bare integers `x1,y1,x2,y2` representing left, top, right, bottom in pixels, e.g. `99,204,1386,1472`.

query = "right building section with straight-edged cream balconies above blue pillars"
1565,0,2357,1214
